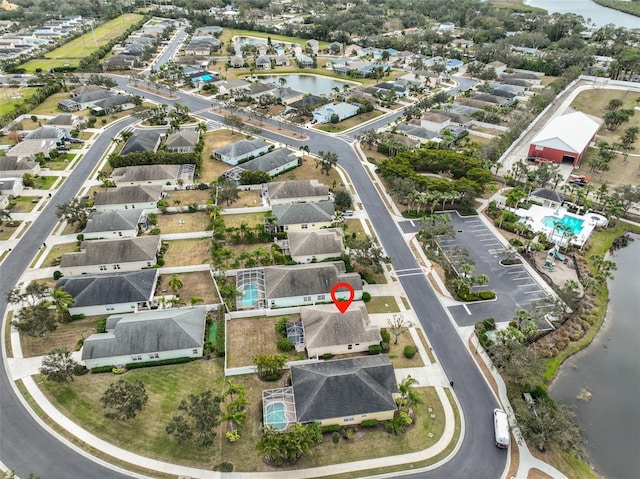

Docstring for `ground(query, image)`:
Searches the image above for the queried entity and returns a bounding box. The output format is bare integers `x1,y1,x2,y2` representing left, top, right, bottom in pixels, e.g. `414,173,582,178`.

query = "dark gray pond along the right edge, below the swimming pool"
550,236,640,479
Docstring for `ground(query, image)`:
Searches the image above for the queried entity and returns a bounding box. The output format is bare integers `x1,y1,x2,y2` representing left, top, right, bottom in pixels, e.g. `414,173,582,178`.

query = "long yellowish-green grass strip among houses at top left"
22,13,142,73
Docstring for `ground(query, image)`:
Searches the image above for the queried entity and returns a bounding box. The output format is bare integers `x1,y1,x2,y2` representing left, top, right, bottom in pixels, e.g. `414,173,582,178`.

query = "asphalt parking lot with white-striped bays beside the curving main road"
400,212,546,326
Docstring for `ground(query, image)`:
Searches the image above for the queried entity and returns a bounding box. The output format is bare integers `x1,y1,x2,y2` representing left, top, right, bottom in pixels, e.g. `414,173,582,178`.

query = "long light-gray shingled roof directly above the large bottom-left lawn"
82,307,206,360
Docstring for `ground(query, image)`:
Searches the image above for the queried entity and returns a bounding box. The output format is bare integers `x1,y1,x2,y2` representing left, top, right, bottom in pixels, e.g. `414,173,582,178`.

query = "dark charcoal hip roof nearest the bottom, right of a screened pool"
290,355,397,423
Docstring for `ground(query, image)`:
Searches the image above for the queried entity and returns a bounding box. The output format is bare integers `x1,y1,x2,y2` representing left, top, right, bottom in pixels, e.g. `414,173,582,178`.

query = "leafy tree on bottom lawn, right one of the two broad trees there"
165,390,221,447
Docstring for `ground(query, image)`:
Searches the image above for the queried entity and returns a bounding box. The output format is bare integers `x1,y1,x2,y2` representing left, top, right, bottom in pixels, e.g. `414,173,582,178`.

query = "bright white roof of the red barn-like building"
531,111,600,153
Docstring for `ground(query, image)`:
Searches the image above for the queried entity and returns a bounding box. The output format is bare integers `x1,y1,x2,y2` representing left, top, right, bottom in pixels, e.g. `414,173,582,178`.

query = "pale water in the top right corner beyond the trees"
524,0,640,28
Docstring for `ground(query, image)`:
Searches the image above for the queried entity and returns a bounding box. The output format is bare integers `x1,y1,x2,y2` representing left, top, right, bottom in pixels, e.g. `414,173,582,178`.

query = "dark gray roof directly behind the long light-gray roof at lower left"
56,269,158,308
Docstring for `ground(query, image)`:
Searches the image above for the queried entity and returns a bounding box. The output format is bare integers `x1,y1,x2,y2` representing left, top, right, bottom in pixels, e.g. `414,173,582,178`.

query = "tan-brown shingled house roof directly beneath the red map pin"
300,302,382,348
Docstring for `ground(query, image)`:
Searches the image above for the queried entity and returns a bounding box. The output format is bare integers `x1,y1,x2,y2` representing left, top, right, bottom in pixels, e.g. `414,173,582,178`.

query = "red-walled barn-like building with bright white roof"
529,111,600,166
